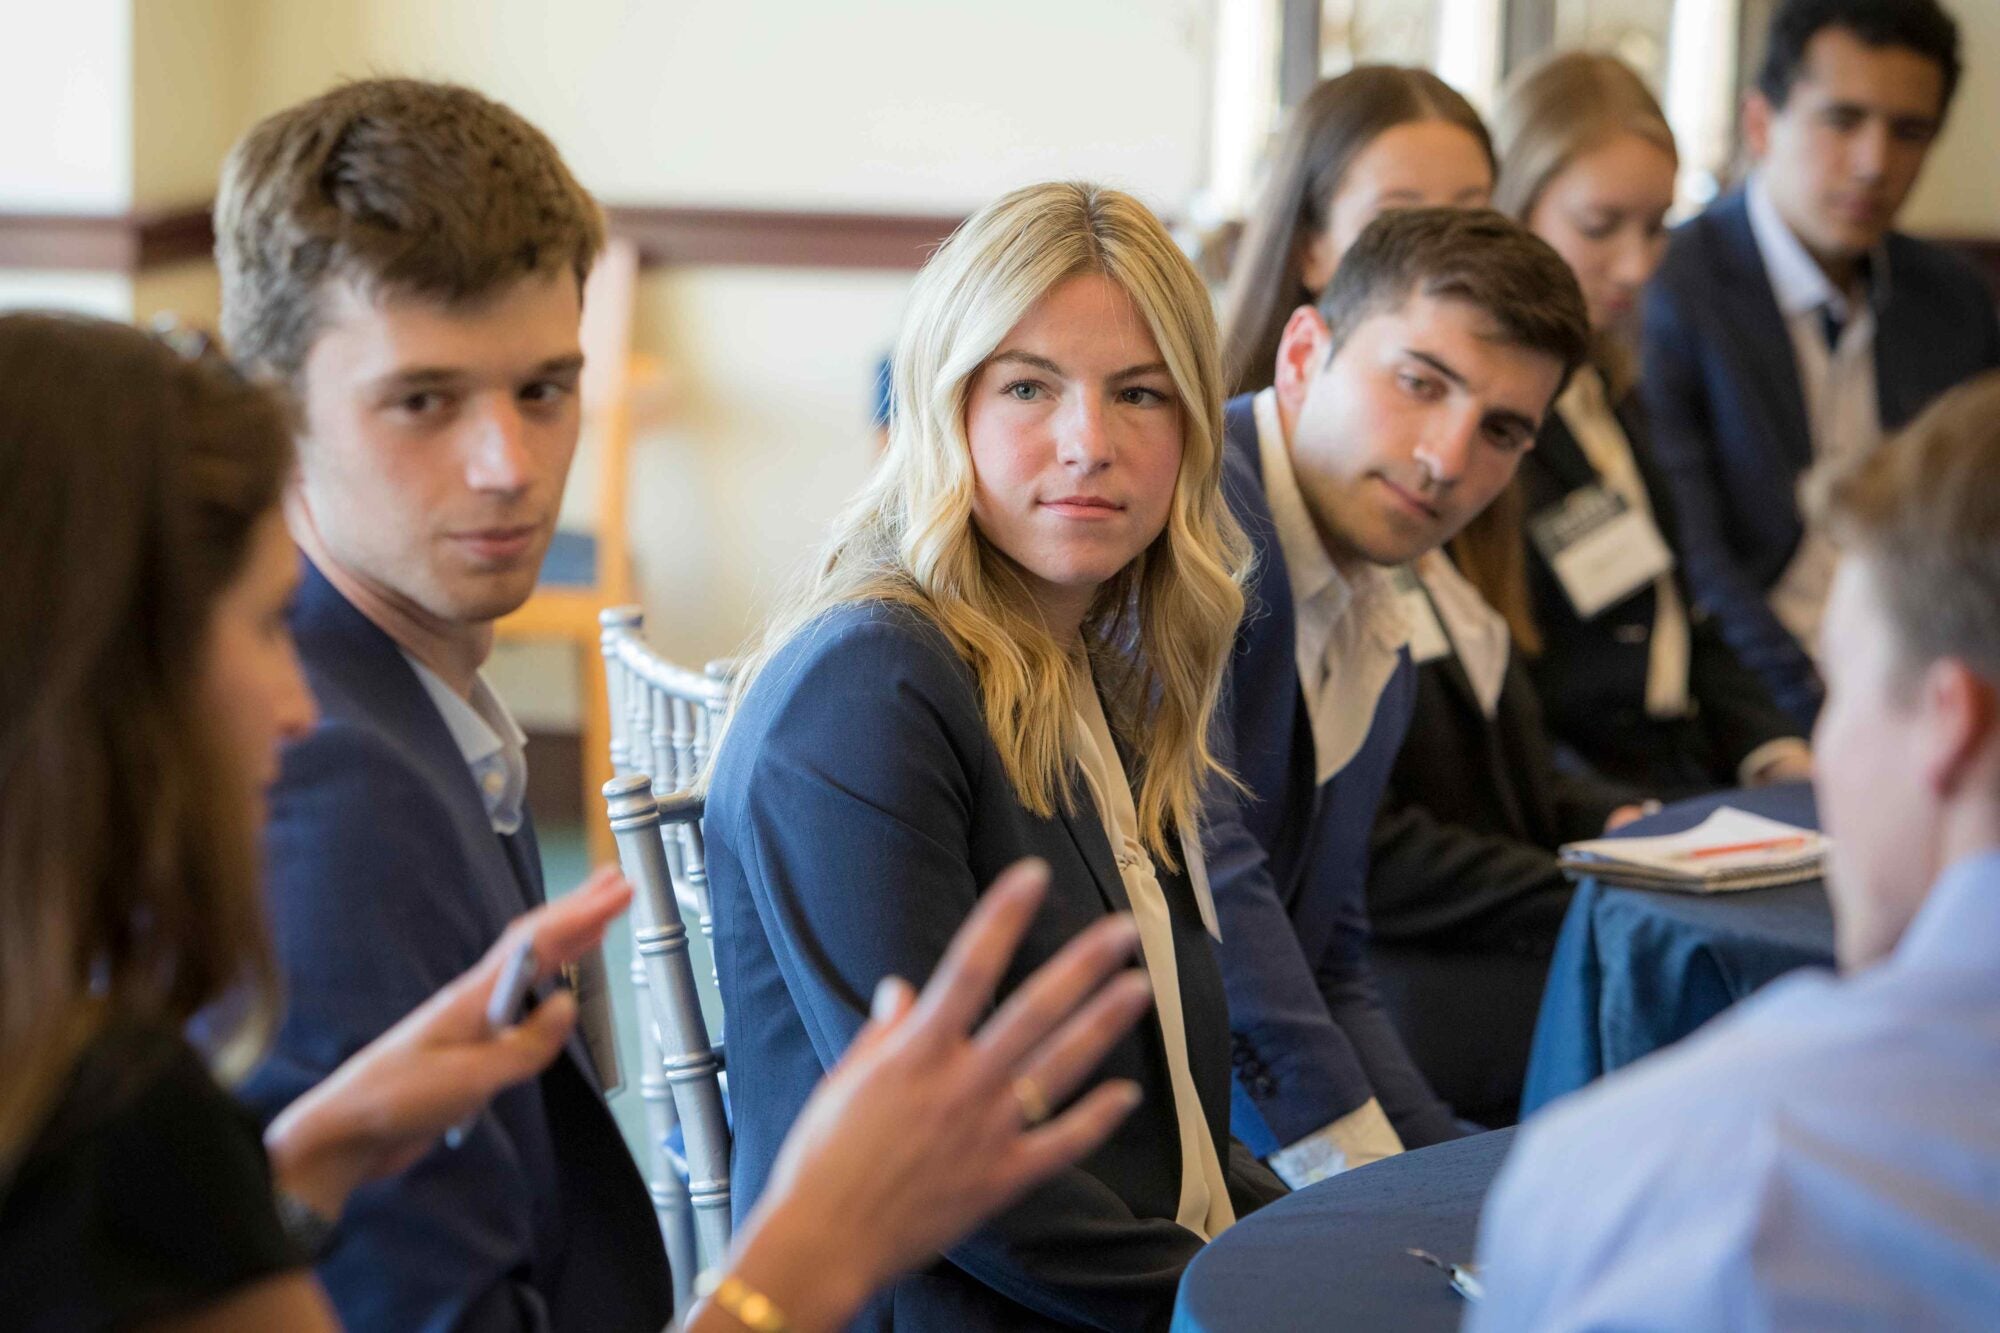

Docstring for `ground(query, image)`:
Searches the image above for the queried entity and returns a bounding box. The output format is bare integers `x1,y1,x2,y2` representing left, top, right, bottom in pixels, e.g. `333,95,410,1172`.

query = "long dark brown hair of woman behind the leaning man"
1222,64,1494,394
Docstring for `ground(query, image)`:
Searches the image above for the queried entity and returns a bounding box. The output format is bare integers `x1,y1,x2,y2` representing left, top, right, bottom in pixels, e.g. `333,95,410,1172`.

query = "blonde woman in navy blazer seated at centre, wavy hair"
708,184,1282,1329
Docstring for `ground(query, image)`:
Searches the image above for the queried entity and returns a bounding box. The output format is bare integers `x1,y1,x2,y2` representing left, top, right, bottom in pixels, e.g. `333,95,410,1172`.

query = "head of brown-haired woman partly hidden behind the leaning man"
1222,64,1496,398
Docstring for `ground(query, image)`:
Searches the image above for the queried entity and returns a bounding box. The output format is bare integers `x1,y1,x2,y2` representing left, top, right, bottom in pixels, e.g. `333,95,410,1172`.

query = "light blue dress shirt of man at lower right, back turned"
1466,855,2000,1333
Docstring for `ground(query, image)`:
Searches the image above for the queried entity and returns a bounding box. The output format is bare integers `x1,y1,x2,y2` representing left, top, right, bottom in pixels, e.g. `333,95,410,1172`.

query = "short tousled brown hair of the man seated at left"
216,78,604,382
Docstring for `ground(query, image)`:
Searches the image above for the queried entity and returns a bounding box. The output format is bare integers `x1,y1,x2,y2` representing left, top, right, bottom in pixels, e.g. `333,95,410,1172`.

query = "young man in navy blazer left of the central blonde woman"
216,80,672,1331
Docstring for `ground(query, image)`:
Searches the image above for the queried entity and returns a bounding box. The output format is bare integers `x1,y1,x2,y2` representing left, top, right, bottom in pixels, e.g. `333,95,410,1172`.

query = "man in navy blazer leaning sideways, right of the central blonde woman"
1204,208,1588,1187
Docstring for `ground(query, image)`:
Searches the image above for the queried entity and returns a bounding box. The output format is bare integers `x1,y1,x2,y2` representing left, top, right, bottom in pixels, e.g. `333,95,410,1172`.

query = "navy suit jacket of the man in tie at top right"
1640,190,2000,727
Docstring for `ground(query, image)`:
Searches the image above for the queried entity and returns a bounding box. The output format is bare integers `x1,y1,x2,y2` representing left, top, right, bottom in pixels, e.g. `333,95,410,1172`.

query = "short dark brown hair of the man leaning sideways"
1320,208,1590,380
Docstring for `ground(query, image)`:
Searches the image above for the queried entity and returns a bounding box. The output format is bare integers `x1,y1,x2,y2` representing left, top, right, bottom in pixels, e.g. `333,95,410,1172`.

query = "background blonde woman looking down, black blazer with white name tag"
1504,52,1810,797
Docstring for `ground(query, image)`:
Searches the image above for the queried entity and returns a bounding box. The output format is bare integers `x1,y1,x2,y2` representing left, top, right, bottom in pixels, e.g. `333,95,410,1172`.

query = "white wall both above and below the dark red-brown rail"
230,0,1210,700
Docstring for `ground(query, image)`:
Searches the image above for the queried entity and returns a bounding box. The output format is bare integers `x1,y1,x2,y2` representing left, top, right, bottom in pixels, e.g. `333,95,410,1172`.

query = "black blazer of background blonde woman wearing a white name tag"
1518,396,1800,801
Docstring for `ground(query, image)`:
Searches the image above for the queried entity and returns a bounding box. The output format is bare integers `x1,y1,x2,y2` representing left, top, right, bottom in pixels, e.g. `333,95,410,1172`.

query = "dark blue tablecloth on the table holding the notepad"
1520,783,1834,1117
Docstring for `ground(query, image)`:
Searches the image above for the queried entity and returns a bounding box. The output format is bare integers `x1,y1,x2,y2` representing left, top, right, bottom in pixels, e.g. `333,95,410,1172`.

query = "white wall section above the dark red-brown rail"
250,0,1210,210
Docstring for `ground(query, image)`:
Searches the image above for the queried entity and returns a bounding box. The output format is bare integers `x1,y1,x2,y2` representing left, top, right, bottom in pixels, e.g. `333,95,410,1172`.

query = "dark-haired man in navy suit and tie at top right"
1640,0,2000,725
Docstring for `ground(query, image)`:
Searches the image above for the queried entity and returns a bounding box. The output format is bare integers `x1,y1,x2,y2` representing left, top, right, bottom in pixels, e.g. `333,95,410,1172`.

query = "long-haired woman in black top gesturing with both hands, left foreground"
0,314,1146,1333
